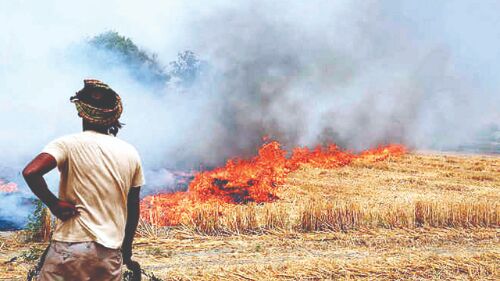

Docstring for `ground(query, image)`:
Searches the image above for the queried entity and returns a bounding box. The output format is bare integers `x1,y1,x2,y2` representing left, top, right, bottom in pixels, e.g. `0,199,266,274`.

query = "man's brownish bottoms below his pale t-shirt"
38,241,122,281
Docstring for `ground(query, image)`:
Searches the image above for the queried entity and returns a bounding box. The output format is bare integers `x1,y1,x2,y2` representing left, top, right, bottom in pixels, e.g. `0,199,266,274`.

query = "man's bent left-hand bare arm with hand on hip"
23,153,77,221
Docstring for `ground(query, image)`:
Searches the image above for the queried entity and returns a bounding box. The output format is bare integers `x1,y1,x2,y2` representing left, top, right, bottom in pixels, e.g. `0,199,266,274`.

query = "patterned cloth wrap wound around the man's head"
70,79,123,126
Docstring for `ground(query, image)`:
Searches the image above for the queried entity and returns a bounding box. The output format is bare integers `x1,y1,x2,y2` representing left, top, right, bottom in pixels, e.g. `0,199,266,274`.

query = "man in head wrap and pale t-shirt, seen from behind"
23,79,144,281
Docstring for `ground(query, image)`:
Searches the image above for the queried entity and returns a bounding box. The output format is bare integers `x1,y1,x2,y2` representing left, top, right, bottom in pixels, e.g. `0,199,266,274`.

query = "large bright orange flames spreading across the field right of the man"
141,141,406,226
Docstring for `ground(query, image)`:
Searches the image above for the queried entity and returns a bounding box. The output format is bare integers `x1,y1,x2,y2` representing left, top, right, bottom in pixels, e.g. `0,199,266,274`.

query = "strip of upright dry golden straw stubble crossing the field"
140,199,500,236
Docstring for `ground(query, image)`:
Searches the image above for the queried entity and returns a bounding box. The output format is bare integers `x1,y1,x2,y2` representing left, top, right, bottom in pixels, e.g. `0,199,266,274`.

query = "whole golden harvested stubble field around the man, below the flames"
0,152,500,280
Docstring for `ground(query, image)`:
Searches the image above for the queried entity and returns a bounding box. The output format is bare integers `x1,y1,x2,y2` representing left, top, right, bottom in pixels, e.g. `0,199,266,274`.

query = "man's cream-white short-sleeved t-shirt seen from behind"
42,131,144,249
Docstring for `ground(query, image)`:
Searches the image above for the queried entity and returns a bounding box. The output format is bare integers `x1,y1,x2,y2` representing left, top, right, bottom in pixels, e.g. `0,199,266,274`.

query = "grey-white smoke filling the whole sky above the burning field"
0,0,500,223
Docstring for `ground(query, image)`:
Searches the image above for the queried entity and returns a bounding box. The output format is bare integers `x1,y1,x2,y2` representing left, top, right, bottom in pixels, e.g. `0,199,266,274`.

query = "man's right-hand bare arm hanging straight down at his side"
122,187,141,270
